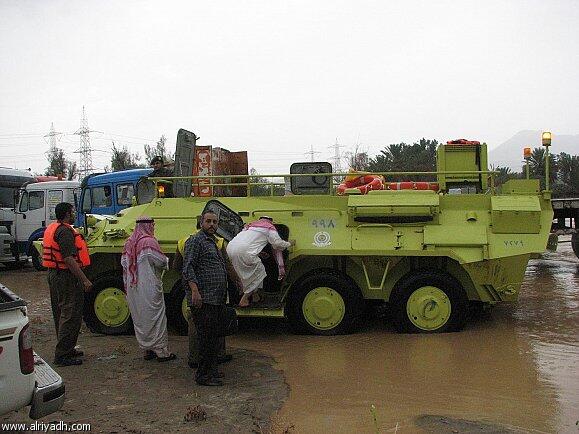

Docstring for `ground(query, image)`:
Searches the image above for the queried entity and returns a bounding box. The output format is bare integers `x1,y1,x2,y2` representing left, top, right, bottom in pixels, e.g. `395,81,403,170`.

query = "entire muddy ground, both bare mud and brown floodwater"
0,239,579,434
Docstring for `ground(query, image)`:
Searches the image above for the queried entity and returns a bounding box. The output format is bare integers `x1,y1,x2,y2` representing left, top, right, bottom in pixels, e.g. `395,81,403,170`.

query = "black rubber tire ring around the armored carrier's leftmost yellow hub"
83,276,134,335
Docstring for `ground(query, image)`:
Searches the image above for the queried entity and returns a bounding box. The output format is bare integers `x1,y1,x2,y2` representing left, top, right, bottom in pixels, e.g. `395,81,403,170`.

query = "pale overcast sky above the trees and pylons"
0,0,579,173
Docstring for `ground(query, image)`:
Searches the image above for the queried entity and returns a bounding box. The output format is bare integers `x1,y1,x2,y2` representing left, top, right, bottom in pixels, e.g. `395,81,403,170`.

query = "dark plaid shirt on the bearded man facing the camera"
183,230,227,305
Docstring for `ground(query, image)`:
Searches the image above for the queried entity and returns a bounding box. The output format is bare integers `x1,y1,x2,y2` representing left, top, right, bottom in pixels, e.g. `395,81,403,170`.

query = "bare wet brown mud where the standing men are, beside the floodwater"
0,267,289,433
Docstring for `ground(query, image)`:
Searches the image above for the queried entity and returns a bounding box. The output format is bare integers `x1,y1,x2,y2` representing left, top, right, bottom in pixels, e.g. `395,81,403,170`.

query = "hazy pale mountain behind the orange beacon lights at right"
489,130,579,171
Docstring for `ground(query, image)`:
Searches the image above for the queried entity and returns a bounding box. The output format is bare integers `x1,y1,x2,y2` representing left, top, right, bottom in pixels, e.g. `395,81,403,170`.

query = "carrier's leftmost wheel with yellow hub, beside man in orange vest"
84,276,133,335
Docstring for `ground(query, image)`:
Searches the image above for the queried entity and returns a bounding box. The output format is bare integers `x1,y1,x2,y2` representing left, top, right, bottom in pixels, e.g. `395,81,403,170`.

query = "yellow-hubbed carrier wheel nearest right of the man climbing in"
285,270,363,335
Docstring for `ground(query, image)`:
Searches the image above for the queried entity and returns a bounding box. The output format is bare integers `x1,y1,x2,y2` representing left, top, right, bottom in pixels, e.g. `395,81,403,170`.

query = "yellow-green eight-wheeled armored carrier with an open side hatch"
76,134,553,335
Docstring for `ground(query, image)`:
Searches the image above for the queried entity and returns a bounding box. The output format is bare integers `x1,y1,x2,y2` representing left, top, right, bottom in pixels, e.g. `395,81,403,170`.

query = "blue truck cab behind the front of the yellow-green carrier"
75,167,153,227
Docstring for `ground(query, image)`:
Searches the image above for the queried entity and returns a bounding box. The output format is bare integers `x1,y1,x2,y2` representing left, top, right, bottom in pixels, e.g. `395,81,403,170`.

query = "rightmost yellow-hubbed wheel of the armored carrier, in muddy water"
390,270,468,333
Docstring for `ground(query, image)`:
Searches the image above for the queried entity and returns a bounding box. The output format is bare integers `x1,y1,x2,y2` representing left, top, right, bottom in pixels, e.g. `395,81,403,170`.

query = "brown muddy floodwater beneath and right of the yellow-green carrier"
232,237,579,433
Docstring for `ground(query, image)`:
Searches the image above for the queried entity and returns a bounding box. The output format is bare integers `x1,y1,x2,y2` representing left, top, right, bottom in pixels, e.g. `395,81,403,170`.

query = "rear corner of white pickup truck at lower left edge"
0,284,64,419
